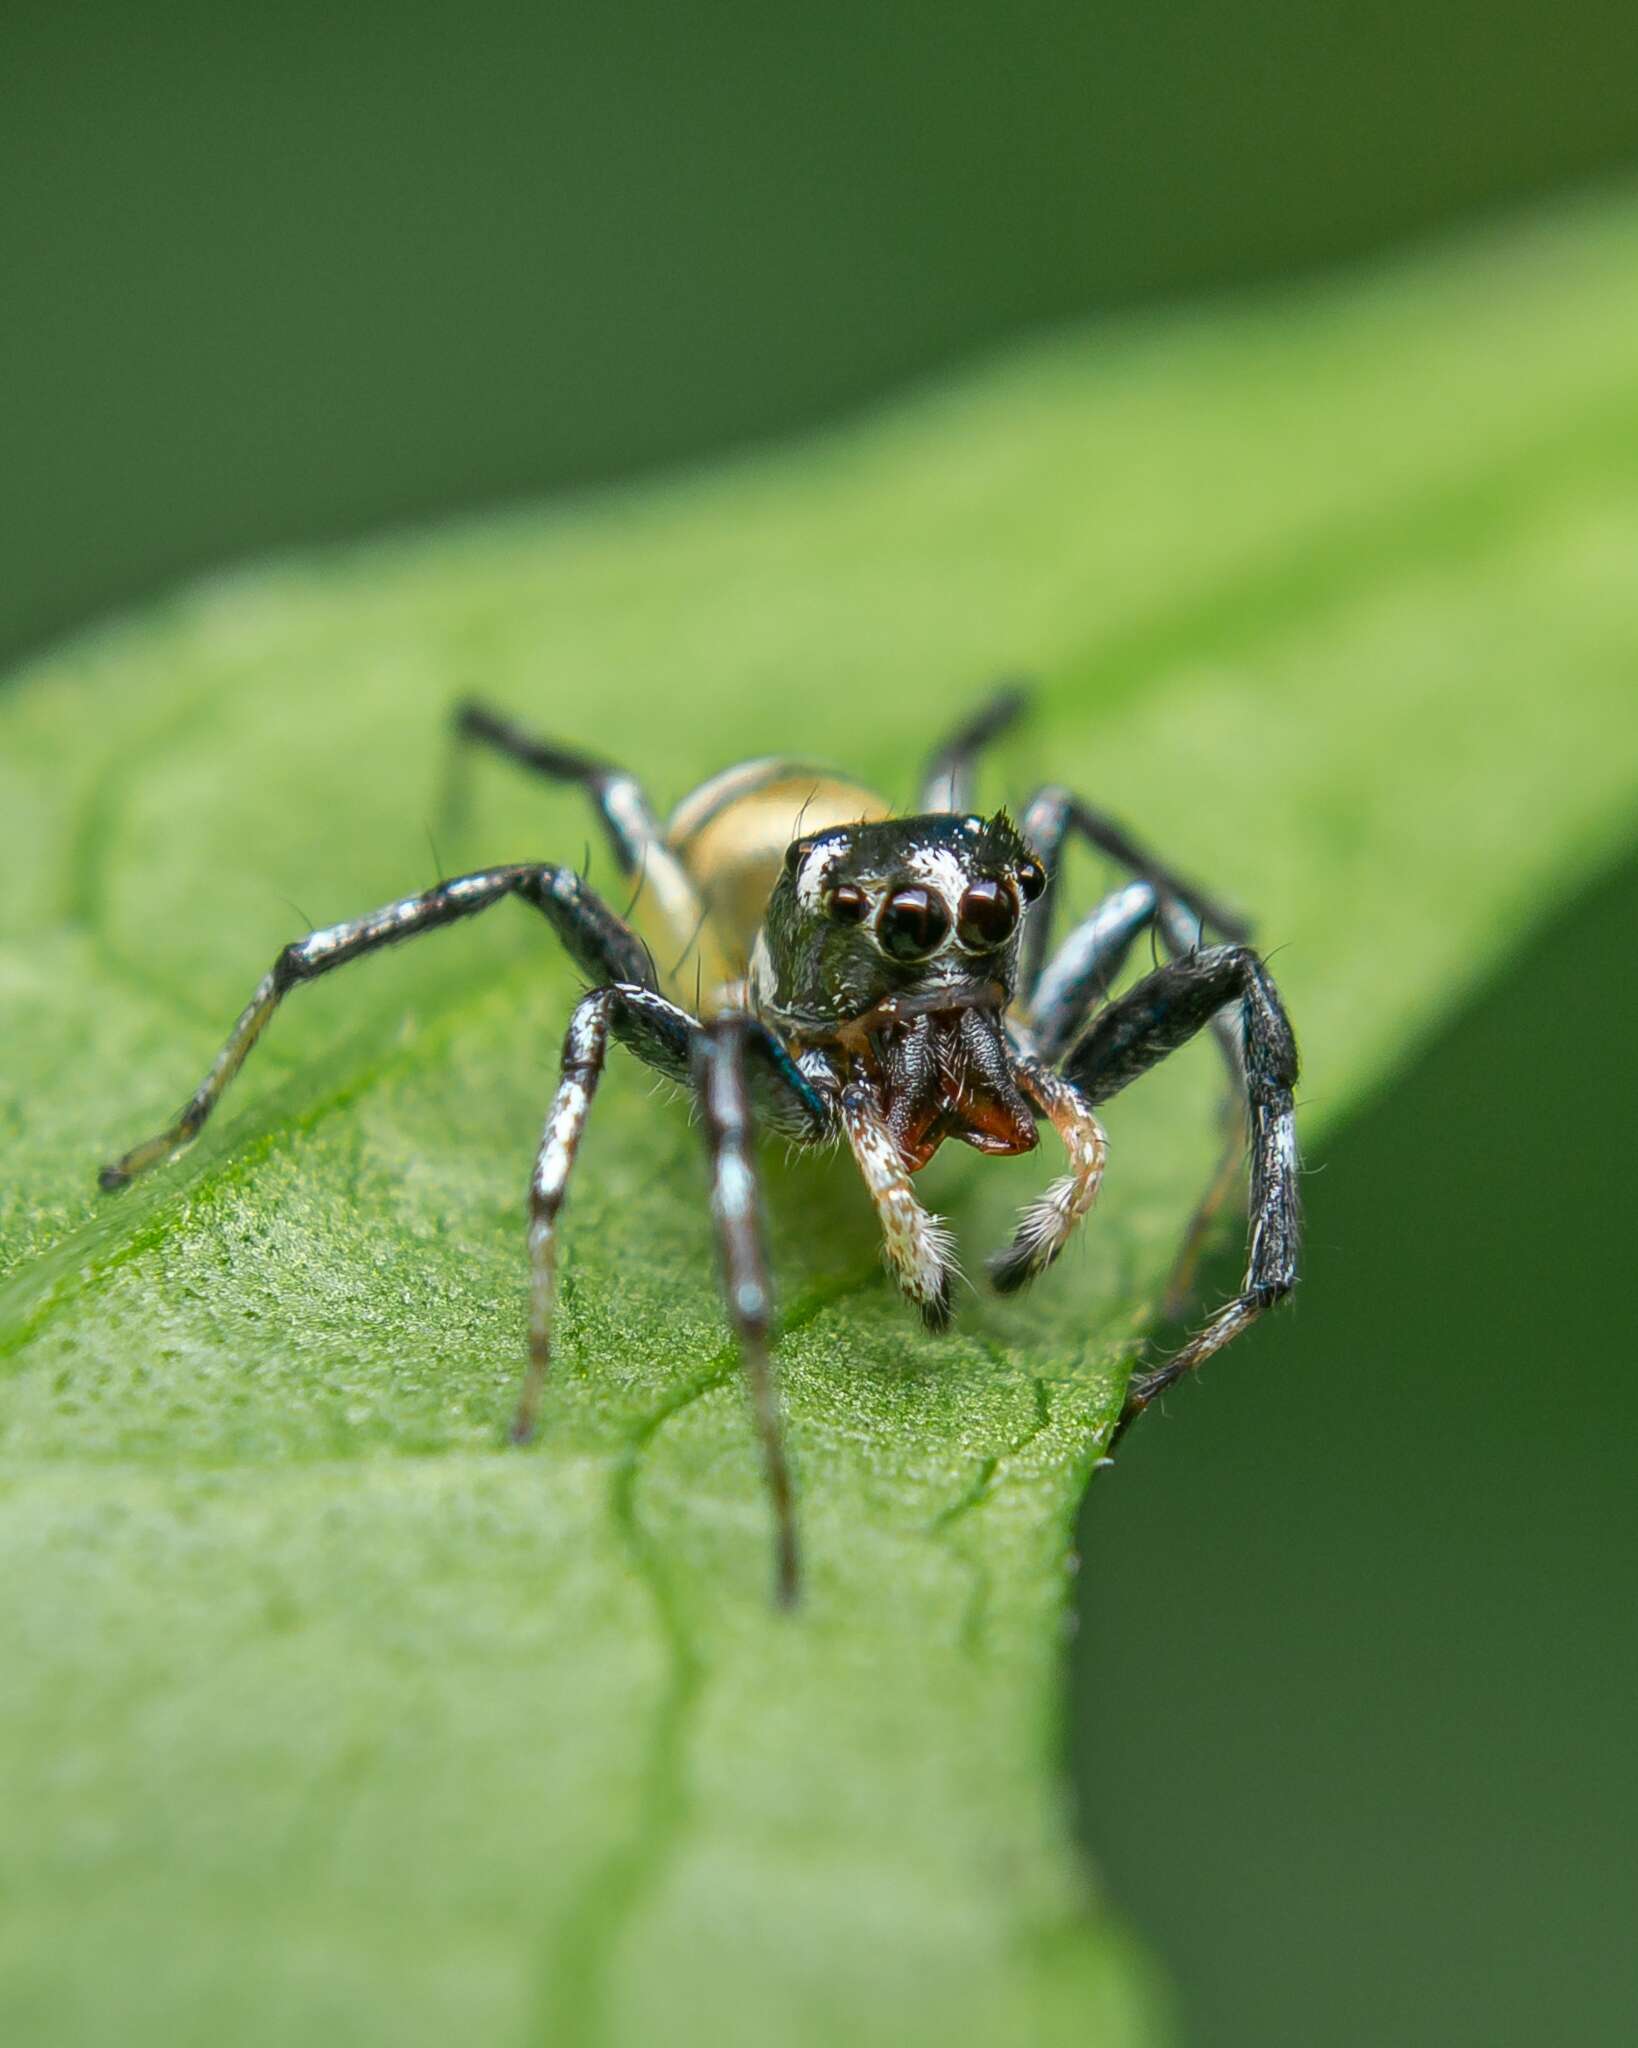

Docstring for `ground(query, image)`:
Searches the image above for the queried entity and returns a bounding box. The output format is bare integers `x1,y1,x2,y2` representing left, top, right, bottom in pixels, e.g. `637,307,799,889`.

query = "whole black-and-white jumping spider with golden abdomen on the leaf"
100,690,1300,1602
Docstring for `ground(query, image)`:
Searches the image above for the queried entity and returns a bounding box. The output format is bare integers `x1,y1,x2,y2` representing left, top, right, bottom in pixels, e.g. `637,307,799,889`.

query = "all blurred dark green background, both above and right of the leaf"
0,0,1638,2044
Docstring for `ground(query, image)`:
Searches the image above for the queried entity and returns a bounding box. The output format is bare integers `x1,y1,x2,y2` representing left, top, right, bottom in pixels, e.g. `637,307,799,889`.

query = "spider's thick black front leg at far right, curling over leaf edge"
1065,946,1302,1434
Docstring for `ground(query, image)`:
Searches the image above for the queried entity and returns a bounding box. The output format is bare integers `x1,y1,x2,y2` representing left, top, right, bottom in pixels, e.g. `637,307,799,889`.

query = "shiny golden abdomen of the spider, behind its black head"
665,758,893,1010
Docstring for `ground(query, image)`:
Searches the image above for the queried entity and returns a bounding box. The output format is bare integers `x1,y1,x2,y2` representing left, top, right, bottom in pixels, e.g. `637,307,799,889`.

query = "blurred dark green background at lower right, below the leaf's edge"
1071,843,1638,2048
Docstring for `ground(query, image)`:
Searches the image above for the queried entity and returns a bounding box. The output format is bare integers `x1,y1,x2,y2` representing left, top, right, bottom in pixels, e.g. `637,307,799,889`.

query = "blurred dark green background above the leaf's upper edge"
0,0,1638,655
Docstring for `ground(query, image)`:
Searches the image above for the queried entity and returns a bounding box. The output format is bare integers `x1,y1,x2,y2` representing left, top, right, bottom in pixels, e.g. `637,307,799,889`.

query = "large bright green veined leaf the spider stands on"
0,184,1638,2048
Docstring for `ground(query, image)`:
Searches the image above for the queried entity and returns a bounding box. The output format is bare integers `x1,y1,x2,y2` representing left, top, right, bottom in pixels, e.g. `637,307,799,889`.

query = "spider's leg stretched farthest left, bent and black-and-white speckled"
98,866,651,1190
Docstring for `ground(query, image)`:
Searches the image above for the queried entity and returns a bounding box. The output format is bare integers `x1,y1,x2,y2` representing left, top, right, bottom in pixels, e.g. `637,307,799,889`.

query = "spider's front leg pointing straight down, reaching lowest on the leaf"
694,1016,799,1608
